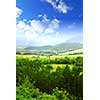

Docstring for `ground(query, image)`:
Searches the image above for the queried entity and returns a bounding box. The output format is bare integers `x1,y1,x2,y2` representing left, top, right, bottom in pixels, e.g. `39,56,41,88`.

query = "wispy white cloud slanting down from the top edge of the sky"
43,0,69,14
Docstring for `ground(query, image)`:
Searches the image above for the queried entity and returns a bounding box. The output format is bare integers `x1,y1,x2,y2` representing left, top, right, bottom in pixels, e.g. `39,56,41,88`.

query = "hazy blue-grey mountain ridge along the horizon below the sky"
16,43,83,52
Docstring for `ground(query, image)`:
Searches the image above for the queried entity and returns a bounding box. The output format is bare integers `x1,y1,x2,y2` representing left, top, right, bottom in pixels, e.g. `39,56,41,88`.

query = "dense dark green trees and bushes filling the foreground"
16,57,83,100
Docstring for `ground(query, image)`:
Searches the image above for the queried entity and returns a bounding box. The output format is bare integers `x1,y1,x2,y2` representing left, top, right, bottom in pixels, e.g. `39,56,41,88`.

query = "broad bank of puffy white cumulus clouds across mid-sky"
16,15,60,34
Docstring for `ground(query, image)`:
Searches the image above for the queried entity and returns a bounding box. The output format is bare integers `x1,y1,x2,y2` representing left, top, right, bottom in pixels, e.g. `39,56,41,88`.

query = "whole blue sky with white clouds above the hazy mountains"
16,0,83,46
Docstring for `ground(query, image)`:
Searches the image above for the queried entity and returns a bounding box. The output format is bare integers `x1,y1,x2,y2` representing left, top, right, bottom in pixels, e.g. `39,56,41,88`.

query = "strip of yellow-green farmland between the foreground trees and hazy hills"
16,49,83,58
